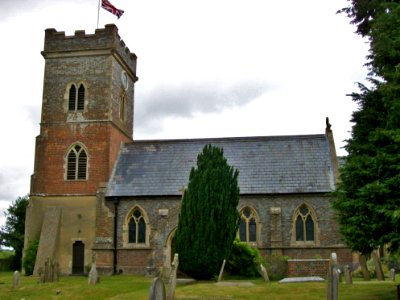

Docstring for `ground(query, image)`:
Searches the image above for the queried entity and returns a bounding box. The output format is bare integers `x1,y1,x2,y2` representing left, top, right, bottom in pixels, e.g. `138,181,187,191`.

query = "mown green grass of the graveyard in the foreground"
0,272,400,300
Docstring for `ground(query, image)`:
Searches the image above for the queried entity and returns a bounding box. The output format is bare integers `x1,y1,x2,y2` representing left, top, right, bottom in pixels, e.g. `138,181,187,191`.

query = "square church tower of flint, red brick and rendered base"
25,25,138,274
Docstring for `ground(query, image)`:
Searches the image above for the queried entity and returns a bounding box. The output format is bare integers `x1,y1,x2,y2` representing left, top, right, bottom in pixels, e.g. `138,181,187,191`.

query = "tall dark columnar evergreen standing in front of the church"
175,145,239,279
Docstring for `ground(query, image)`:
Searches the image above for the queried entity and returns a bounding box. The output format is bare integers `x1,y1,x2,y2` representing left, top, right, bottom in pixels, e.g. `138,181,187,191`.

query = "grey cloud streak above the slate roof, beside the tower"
135,81,268,131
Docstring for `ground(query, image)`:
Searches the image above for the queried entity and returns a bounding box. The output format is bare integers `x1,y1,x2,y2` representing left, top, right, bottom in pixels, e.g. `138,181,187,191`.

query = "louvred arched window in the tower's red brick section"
67,145,88,180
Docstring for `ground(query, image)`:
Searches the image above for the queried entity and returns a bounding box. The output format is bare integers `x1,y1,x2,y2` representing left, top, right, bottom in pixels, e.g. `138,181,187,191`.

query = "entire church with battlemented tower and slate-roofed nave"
25,24,352,275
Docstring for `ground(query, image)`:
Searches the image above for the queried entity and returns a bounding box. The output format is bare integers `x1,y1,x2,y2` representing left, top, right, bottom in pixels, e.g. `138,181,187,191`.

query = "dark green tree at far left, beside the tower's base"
0,196,29,269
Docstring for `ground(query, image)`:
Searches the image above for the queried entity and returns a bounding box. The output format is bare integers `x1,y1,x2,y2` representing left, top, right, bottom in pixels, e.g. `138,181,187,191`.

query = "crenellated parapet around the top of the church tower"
42,24,137,76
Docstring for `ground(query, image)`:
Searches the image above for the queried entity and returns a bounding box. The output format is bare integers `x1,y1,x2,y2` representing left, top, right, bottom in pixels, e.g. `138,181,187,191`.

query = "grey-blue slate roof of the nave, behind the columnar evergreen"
106,134,334,197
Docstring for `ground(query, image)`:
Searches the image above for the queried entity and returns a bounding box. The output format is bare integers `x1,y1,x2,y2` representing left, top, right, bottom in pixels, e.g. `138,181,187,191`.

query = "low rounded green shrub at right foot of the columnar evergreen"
226,239,262,277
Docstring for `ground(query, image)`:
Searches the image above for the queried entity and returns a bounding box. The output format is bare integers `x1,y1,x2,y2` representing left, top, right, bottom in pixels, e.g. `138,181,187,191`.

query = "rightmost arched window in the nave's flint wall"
293,204,317,243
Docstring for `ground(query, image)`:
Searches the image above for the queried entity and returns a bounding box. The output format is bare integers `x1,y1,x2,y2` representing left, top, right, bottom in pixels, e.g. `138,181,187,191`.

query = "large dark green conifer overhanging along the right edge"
333,0,400,254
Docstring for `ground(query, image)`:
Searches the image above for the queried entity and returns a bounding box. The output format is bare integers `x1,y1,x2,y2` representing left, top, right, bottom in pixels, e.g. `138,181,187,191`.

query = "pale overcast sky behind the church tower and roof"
0,0,368,224
